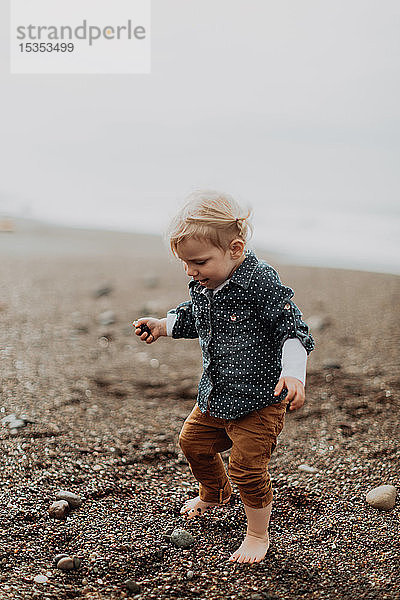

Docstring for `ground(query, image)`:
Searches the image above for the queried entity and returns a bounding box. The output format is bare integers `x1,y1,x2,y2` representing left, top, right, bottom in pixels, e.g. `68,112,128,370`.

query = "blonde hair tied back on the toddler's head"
167,190,253,256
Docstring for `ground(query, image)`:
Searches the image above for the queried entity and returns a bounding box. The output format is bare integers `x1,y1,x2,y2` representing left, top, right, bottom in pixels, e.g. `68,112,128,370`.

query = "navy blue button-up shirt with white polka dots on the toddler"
168,250,314,419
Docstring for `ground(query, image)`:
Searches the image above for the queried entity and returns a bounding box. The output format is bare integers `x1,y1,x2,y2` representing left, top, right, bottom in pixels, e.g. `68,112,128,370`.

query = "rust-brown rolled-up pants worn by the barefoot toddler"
179,400,287,508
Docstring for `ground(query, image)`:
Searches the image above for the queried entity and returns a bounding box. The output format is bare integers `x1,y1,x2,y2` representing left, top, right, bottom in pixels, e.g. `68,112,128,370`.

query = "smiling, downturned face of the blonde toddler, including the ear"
177,238,245,290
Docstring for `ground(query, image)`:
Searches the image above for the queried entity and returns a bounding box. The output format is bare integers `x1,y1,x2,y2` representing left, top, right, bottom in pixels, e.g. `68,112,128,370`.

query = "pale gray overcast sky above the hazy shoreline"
0,0,400,270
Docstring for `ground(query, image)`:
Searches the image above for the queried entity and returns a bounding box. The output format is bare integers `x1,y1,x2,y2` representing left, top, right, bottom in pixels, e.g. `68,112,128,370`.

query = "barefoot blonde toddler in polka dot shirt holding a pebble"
135,192,314,563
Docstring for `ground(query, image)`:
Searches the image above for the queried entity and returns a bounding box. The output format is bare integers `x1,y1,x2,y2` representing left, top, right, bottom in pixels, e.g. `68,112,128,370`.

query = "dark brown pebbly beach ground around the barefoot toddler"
0,221,400,600
